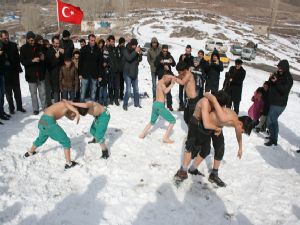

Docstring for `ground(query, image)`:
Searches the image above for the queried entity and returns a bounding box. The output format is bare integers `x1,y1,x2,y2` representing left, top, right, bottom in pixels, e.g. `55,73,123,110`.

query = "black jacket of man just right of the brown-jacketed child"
78,45,103,79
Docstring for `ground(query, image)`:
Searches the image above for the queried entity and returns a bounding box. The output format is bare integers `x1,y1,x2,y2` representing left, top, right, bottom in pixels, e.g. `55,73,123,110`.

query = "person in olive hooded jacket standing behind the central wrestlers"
147,37,161,101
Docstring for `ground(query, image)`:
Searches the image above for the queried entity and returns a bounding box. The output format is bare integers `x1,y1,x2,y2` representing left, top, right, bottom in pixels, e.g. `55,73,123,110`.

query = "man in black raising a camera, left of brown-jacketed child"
46,36,64,102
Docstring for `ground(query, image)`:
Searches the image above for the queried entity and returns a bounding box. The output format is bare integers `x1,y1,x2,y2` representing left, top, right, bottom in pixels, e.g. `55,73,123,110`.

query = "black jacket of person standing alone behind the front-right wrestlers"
223,66,246,102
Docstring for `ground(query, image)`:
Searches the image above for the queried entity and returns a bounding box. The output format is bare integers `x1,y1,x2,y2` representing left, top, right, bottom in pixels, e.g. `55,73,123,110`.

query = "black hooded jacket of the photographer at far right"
269,71,293,107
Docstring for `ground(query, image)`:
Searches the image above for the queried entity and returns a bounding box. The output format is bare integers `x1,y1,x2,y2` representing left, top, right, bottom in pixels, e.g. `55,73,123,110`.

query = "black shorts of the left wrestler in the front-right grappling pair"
185,116,212,158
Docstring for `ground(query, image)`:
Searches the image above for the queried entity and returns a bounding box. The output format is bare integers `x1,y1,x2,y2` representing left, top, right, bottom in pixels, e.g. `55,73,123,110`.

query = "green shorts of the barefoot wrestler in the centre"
150,102,176,125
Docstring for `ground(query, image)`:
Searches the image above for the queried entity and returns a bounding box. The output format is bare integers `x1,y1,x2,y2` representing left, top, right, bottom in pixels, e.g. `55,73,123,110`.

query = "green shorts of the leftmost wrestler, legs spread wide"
33,115,71,149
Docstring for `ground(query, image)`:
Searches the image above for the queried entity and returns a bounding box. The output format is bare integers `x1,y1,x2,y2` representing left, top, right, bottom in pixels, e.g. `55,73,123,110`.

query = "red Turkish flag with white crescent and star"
57,0,83,24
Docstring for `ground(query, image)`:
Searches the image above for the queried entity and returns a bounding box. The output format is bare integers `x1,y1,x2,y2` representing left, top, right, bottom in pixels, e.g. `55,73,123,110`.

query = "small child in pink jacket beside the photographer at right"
248,87,264,125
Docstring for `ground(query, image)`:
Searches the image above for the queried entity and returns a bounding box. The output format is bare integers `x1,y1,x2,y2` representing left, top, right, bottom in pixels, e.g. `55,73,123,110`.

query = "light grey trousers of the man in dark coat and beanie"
28,80,46,112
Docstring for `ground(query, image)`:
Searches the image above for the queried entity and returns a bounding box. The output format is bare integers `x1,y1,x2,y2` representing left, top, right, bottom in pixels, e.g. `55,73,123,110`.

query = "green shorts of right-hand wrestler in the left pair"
90,109,110,144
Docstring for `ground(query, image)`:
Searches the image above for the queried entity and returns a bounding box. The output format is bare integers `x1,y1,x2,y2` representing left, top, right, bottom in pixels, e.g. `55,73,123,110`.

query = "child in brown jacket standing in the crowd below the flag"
59,57,79,101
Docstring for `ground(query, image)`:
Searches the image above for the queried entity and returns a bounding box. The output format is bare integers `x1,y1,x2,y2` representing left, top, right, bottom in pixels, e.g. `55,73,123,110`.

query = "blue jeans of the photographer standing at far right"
267,105,285,142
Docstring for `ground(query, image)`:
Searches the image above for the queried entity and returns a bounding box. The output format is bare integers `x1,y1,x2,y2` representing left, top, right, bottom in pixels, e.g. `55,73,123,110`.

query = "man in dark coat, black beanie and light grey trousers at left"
20,31,46,115
